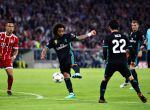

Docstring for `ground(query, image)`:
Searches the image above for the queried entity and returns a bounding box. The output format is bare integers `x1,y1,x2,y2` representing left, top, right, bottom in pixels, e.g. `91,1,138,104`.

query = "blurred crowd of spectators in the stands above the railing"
0,0,150,48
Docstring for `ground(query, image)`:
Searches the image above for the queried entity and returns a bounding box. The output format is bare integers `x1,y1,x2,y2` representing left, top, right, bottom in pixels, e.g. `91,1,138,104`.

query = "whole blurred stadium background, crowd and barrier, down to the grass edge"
0,0,150,68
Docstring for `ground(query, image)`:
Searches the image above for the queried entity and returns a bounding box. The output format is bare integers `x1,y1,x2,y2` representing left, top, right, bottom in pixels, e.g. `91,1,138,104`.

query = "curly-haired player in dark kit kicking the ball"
41,24,96,98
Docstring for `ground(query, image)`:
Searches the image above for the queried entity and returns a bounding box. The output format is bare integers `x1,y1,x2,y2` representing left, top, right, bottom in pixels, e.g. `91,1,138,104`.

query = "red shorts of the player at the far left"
0,59,13,69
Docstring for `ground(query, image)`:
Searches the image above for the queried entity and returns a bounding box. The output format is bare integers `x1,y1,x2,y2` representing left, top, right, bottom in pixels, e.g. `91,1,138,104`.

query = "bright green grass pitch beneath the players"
0,69,150,110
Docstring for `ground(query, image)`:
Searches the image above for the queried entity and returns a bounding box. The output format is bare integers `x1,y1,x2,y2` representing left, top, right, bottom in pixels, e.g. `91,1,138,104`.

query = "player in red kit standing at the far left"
0,19,18,95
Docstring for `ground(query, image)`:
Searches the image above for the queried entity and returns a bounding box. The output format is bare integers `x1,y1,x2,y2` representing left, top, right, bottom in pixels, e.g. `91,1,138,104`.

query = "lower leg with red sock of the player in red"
6,67,13,95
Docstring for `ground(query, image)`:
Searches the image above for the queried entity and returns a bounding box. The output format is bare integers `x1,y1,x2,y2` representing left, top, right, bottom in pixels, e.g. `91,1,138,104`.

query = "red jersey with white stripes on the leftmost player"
0,32,19,60
